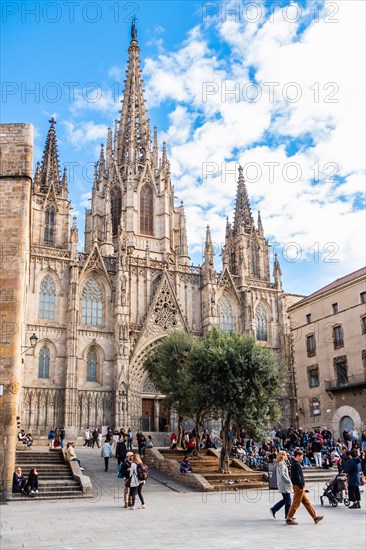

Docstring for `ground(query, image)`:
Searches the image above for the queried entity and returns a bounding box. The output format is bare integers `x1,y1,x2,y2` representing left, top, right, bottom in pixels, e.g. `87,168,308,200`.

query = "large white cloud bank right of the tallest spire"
144,1,365,284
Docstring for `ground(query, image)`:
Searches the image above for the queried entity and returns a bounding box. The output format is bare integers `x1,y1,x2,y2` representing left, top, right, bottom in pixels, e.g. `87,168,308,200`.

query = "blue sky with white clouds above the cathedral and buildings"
1,0,365,294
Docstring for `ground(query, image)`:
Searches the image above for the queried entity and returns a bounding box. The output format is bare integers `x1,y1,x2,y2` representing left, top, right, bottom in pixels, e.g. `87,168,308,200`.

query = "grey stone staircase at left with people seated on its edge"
9,448,85,501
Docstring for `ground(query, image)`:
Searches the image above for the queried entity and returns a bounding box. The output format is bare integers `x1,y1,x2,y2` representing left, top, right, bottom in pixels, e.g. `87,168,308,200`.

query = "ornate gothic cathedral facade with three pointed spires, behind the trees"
21,26,294,437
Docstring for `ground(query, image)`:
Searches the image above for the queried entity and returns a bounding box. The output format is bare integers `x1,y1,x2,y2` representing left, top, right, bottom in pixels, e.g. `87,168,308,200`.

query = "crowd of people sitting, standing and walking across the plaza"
13,426,366,525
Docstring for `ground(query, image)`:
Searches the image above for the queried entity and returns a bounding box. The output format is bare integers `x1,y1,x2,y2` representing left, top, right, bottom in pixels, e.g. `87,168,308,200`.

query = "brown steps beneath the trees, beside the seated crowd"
159,449,268,491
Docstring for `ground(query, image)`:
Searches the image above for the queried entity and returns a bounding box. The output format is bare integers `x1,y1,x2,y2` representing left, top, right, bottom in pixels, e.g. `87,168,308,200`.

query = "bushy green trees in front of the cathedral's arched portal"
145,327,285,471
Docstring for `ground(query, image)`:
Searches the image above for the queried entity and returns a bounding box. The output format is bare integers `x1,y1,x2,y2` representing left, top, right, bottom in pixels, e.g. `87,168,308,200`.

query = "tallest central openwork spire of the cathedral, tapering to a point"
117,18,151,166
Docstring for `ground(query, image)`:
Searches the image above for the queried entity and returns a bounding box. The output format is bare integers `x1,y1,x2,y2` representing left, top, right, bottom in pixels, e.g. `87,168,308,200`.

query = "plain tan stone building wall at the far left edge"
0,124,33,496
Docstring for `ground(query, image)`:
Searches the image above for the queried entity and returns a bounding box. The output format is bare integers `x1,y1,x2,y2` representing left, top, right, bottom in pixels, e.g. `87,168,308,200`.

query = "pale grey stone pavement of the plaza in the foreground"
0,448,366,550
